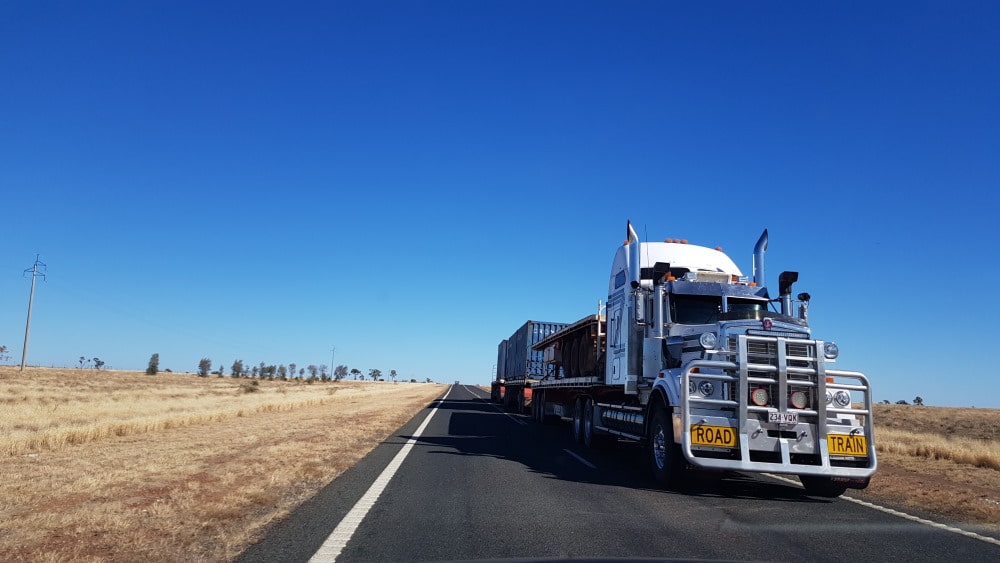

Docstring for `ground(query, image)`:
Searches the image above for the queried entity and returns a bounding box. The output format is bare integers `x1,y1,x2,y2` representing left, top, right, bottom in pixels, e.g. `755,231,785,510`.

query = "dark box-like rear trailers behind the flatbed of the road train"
490,321,566,412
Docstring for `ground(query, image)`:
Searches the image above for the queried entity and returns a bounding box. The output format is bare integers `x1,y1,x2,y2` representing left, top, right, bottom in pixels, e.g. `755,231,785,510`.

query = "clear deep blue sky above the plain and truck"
0,1,1000,407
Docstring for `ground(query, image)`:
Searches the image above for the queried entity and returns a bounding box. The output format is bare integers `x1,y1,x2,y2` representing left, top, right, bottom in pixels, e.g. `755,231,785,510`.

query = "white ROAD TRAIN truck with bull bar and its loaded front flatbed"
530,224,877,496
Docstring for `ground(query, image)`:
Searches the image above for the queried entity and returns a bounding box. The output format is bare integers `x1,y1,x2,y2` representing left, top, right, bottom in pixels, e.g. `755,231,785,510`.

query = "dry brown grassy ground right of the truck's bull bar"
848,405,1000,537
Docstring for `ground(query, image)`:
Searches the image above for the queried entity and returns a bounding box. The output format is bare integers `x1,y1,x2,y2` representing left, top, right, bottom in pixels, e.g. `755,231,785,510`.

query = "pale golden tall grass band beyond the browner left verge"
0,367,369,455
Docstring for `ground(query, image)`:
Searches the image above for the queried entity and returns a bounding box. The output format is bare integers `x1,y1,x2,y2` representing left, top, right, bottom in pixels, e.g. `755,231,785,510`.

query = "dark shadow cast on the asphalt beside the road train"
398,399,831,504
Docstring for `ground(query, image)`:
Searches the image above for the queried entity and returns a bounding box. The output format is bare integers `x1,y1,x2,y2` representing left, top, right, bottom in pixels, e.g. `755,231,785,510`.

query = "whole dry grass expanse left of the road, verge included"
0,367,445,561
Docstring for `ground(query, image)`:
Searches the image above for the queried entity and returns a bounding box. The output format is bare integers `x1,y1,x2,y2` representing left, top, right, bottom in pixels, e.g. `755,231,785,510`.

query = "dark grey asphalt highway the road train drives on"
239,386,1000,562
